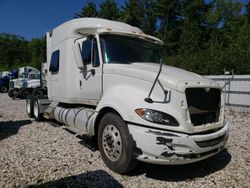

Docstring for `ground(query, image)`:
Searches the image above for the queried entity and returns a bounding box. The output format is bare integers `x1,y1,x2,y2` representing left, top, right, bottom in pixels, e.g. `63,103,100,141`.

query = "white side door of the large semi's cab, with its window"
79,37,102,101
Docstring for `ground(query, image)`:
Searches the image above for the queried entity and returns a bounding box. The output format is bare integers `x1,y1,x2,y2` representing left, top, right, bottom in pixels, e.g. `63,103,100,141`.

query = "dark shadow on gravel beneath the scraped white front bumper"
128,149,232,182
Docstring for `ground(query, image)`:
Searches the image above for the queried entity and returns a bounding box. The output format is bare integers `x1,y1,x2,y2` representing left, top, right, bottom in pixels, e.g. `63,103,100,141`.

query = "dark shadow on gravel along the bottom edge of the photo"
28,170,123,188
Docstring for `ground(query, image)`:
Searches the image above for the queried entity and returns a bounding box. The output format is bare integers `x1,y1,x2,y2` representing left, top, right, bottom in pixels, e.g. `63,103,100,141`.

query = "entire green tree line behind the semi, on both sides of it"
0,0,250,74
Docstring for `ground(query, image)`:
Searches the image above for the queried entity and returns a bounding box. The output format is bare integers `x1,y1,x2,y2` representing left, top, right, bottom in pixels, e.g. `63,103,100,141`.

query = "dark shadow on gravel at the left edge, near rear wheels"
0,120,32,141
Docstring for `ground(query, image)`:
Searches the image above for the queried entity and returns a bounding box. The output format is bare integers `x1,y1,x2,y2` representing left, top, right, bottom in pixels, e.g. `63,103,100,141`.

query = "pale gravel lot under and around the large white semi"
0,93,250,187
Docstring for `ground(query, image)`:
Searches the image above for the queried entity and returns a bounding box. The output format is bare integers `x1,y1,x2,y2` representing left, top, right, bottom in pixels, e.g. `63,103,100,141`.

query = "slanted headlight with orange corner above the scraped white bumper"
135,108,179,127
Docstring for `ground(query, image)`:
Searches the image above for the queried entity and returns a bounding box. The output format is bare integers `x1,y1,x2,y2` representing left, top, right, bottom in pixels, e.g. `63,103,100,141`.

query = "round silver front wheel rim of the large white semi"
102,125,122,161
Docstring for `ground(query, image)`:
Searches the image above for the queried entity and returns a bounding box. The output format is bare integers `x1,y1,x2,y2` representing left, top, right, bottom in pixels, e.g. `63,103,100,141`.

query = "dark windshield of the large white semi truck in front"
100,34,161,64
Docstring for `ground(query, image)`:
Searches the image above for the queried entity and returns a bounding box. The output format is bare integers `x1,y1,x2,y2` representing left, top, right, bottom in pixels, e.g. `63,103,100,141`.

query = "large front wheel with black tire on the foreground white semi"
98,113,137,174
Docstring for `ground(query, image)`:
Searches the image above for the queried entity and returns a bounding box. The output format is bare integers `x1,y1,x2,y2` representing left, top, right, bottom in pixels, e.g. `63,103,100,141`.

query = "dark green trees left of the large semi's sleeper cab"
0,33,46,71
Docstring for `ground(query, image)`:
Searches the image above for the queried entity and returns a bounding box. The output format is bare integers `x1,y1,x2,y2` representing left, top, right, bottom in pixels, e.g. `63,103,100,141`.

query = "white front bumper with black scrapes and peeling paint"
128,122,229,164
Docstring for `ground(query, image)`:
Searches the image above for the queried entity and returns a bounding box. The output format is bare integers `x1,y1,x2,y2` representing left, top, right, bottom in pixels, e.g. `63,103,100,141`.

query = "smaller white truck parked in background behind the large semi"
8,66,43,99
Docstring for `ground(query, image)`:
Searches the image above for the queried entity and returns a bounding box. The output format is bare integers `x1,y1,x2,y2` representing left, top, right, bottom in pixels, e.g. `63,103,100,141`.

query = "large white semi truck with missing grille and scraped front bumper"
26,18,229,174
